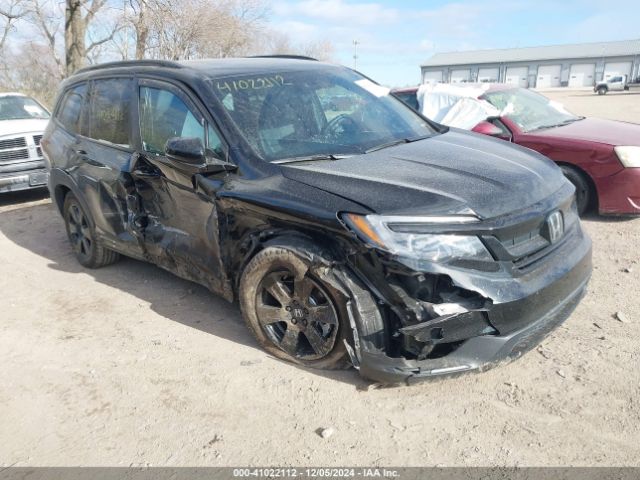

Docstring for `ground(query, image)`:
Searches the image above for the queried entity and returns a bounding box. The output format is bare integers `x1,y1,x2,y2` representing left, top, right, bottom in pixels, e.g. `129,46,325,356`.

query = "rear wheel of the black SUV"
62,192,120,268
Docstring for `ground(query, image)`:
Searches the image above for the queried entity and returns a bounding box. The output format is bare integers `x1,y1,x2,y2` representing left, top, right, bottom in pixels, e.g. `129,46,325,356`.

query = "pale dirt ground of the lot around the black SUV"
0,91,640,466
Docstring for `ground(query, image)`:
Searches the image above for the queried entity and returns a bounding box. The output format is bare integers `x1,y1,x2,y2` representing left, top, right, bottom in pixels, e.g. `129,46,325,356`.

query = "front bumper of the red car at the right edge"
597,168,640,215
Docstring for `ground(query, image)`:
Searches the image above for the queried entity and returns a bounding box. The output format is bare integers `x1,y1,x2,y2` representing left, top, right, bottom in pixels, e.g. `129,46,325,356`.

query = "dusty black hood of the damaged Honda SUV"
282,129,566,218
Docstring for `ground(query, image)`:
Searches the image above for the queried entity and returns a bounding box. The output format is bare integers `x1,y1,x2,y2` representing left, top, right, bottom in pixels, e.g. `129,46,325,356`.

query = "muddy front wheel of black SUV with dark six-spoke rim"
239,246,350,370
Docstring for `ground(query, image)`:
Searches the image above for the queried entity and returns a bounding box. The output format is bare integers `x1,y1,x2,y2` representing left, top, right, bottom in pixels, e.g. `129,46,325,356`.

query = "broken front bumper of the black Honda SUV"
352,216,592,383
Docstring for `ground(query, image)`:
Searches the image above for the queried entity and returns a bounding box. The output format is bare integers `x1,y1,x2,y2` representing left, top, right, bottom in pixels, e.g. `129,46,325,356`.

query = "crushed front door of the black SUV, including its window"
131,79,228,292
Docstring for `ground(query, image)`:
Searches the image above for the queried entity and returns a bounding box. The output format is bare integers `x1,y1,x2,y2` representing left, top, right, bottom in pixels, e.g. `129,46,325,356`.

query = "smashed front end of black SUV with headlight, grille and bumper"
342,189,591,383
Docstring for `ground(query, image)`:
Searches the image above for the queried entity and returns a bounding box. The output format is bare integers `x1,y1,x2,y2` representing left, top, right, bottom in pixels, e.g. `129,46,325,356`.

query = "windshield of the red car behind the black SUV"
482,88,582,132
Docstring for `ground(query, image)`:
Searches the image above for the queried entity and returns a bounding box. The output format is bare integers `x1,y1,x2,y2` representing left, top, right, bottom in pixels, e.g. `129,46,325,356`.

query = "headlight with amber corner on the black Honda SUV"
342,213,493,262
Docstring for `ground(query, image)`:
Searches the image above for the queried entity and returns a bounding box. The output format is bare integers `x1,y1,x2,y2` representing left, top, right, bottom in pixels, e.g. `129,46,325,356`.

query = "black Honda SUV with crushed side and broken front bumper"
42,57,591,383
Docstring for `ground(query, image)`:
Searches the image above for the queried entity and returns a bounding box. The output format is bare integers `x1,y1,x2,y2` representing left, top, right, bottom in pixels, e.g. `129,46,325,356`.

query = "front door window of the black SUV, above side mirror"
140,87,205,154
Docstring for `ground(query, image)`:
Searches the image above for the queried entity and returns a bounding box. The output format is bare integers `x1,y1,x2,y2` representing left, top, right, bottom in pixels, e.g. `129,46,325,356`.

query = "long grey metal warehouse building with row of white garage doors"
421,40,640,88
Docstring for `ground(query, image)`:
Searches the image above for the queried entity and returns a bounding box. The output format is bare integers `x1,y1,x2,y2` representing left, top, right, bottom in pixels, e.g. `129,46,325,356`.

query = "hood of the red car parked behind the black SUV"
531,118,640,146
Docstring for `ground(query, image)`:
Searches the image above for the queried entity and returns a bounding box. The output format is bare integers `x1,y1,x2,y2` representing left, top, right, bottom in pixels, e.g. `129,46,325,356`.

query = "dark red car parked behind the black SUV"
392,84,640,215
